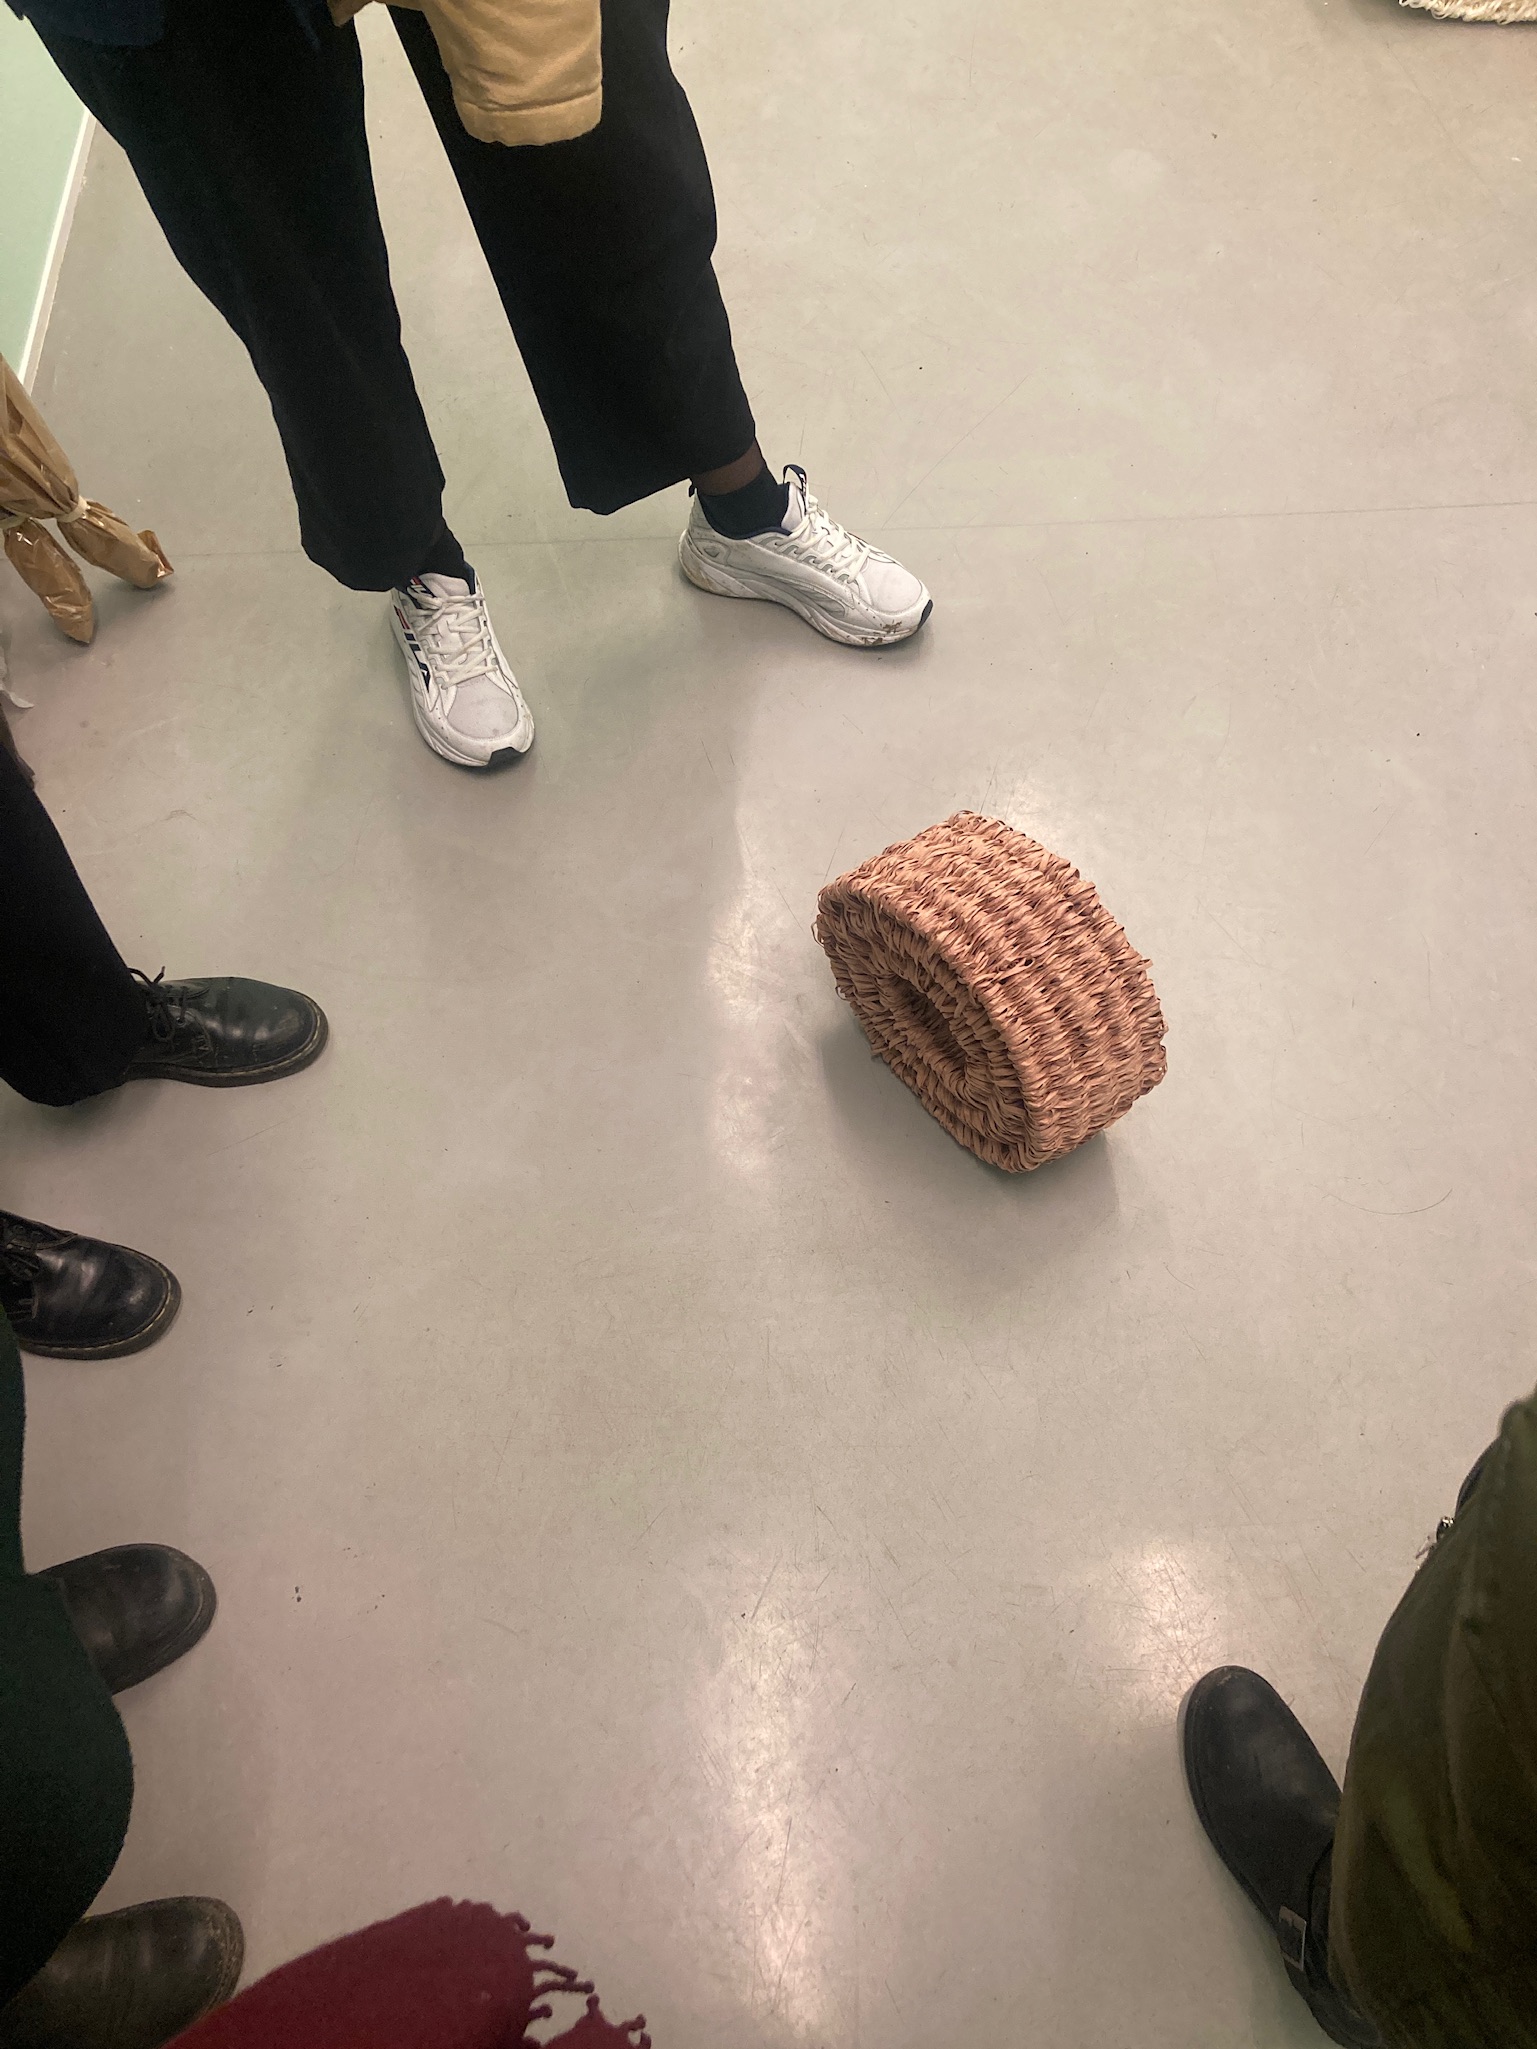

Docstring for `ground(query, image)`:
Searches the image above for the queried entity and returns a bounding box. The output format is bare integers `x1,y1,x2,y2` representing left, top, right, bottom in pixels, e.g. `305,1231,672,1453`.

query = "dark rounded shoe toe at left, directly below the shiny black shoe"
37,1543,219,1692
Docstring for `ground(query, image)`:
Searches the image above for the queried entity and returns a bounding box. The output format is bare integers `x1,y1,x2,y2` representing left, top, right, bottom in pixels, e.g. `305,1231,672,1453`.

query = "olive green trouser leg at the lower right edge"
1330,1395,1537,2049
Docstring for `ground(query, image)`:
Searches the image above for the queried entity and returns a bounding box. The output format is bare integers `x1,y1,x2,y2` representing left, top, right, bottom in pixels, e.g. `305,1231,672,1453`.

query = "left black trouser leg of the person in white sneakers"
43,0,443,590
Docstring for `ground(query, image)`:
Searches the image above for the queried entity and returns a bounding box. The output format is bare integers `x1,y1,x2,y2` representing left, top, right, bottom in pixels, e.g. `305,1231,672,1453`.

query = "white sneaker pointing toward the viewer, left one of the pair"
389,572,533,768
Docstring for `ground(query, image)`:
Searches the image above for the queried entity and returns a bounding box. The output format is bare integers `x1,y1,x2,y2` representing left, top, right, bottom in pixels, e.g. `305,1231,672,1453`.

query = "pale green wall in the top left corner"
0,6,80,365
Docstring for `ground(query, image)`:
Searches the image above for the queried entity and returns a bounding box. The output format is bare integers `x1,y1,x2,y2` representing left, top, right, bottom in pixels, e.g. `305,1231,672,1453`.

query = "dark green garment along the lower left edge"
0,1313,133,2002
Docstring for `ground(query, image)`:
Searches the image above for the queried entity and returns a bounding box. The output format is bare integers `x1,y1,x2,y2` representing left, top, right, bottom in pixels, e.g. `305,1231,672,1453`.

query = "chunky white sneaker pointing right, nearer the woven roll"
678,463,934,647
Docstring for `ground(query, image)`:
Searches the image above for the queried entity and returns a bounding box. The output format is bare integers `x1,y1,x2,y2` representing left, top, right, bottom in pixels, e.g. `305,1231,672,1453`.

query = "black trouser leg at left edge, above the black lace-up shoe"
0,748,148,1104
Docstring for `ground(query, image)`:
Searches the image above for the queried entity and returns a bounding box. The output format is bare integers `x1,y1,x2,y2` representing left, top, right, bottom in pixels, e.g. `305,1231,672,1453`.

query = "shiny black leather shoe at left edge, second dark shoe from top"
0,1209,182,1358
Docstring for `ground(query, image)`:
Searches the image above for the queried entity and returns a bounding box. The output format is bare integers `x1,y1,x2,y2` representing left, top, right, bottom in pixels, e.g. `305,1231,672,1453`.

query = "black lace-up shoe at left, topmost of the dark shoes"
123,975,330,1088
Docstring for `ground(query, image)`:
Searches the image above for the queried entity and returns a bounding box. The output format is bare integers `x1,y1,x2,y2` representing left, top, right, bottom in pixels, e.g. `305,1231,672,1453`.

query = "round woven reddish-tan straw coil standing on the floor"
816,811,1166,1174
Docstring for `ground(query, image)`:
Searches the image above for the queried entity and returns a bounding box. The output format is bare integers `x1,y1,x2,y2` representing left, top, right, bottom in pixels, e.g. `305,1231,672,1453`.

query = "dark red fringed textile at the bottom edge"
176,1899,652,2049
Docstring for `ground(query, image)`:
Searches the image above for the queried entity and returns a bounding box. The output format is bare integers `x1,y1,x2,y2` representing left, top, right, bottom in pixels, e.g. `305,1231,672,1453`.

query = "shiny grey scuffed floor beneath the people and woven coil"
0,0,1537,2049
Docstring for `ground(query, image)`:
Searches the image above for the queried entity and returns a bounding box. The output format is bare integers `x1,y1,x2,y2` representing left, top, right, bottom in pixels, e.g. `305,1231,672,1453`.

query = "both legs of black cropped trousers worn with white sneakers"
45,0,754,590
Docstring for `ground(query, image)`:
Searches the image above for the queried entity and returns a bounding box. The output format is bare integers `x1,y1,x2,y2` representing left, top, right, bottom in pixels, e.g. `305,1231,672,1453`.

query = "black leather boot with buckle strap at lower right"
1180,1666,1381,2049
